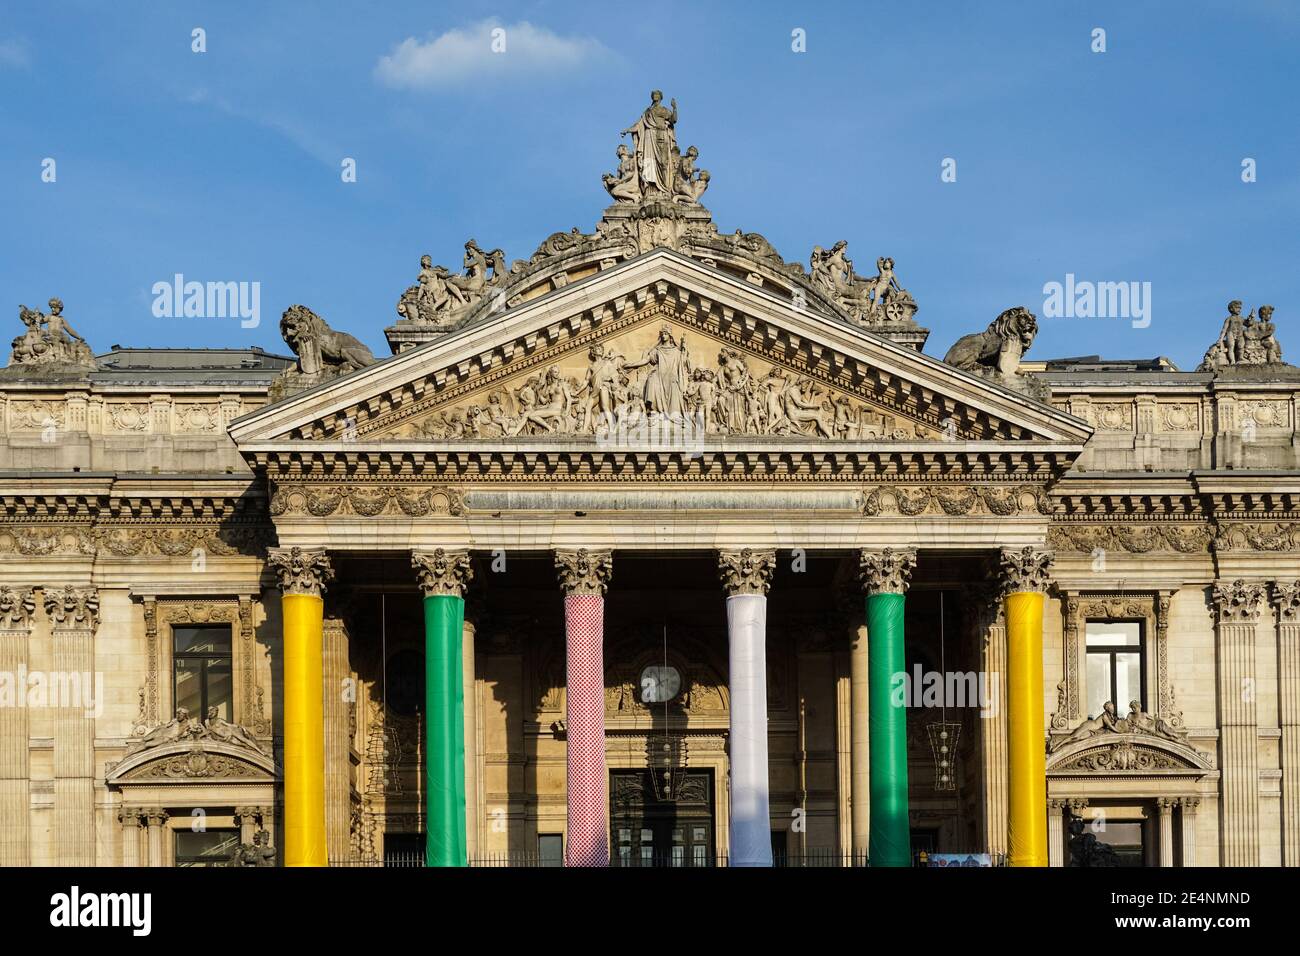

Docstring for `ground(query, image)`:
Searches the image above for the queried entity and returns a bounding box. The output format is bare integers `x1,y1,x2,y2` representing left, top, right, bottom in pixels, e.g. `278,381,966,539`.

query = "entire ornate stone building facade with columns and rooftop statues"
0,94,1300,866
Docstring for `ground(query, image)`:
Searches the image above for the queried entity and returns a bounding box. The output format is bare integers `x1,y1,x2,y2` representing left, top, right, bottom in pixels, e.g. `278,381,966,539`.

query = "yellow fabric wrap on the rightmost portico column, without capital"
1006,591,1048,866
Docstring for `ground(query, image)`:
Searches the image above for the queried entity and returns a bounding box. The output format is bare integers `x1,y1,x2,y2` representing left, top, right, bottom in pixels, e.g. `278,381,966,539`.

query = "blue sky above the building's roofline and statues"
0,0,1300,368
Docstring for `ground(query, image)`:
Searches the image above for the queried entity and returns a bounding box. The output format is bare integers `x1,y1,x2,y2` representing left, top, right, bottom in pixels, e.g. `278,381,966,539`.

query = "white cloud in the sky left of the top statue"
374,20,611,90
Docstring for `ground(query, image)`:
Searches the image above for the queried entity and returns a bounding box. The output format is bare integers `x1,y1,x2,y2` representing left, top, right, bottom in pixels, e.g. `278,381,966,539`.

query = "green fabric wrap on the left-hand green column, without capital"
424,594,468,866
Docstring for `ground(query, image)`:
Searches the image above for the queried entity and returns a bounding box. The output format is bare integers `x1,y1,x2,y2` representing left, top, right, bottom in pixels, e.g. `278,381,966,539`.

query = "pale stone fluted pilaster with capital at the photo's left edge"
0,588,36,866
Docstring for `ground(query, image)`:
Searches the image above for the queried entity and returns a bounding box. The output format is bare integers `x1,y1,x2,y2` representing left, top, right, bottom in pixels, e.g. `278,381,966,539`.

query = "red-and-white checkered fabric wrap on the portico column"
564,594,610,866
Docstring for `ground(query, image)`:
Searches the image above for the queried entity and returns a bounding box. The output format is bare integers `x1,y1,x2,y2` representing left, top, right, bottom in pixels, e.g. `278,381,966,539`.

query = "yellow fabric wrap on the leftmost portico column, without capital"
281,594,329,866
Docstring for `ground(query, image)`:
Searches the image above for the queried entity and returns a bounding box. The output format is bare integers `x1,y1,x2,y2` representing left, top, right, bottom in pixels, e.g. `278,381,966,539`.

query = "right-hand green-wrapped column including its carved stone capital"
858,548,917,866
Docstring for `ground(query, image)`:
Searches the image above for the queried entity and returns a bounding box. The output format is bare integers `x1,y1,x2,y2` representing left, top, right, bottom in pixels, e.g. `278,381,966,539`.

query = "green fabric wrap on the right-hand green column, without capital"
867,593,911,866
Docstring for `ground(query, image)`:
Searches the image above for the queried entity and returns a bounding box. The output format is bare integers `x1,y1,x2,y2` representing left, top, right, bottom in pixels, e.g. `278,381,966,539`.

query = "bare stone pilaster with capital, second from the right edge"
1214,580,1264,866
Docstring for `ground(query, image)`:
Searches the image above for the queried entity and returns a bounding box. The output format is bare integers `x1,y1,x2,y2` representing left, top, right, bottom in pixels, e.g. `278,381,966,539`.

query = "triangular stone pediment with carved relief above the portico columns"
230,250,1091,460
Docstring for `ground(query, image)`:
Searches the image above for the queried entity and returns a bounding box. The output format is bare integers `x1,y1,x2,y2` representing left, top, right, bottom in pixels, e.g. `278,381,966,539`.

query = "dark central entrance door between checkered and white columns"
610,770,714,866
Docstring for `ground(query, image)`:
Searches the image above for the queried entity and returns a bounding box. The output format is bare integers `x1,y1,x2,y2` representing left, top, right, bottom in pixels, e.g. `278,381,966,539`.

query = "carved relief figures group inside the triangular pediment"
413,325,911,440
